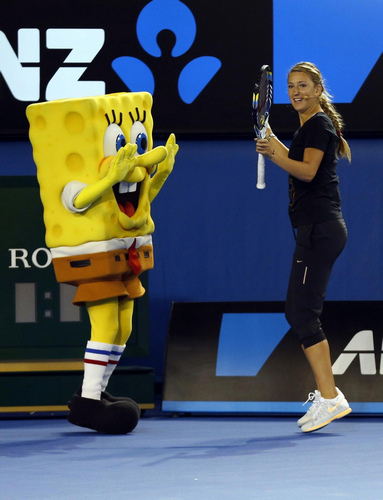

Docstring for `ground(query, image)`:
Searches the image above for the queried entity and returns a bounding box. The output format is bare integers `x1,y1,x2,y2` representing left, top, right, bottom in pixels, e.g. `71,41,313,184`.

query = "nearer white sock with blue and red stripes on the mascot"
81,340,113,400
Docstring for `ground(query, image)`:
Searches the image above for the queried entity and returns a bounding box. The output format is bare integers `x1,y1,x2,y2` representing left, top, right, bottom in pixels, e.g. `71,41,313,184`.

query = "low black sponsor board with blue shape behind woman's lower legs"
163,301,383,414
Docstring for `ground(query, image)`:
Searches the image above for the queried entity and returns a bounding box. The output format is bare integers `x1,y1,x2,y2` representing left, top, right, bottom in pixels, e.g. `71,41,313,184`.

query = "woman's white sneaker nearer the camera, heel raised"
301,388,352,432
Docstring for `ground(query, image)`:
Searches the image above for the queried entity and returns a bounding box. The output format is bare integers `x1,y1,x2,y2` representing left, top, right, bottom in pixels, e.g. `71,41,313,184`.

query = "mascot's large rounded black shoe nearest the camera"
68,394,139,434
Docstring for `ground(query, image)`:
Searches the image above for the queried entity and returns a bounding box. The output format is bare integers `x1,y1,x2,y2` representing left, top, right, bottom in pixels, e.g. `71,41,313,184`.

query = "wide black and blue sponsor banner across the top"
0,0,383,137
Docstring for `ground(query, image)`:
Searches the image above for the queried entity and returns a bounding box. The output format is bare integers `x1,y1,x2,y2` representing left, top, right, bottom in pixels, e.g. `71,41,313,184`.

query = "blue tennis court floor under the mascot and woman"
0,412,383,500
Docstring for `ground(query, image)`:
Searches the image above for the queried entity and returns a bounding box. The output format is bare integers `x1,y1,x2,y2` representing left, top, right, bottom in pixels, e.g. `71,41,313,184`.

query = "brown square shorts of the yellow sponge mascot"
52,245,154,305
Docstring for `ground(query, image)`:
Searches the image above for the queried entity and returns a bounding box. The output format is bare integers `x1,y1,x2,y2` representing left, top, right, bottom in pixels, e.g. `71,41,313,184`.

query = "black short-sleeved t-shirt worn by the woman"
289,112,342,227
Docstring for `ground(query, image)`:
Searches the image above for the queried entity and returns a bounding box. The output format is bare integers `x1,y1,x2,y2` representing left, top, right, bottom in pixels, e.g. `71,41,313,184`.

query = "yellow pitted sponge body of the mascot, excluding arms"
26,92,154,248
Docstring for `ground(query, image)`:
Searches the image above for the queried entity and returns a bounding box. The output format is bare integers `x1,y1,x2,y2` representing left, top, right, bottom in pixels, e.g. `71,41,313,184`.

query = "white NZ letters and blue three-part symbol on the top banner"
0,0,222,104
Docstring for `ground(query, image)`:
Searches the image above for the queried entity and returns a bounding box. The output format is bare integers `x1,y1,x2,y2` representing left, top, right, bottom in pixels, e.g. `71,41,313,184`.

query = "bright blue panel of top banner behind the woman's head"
273,0,383,104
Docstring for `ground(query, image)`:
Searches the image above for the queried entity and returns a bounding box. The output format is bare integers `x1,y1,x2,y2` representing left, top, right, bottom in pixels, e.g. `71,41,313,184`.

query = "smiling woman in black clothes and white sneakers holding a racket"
256,62,351,432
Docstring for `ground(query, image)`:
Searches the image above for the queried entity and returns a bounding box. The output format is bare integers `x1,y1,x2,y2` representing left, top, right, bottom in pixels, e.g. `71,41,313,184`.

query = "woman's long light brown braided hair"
289,62,351,162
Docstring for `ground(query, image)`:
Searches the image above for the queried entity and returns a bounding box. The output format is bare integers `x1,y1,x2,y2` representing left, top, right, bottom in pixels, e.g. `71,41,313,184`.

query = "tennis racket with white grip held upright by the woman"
253,65,273,189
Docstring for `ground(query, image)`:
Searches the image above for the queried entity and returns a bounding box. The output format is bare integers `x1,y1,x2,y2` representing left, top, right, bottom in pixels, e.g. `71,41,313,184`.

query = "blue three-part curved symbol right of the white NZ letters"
112,0,222,104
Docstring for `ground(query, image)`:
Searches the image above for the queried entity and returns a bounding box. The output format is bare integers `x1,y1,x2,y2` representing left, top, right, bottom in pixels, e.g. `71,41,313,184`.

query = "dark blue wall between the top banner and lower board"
0,139,383,380
